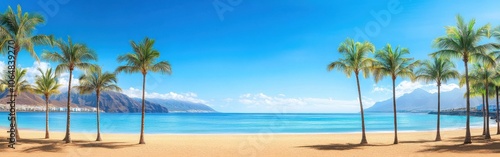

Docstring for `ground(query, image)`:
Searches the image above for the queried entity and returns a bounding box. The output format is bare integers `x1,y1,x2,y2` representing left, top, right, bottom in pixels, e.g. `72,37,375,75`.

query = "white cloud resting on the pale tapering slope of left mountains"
122,87,208,104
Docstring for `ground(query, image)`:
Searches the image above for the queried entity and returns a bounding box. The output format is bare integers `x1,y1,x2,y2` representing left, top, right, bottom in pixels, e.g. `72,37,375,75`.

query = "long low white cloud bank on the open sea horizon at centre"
238,93,375,112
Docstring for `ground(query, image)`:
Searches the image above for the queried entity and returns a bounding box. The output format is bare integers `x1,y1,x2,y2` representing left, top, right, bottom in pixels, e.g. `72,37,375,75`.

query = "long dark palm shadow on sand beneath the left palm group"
0,138,138,153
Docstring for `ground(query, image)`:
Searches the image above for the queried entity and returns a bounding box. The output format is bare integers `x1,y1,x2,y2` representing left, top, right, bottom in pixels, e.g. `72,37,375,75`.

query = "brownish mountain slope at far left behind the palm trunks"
0,90,81,107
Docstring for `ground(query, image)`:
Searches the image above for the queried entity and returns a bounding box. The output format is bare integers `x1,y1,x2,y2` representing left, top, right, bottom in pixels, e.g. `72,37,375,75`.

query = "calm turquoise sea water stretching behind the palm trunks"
0,112,482,134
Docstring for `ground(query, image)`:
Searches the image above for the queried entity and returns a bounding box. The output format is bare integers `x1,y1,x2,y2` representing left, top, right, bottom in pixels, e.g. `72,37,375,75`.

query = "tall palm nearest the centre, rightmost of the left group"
116,37,172,144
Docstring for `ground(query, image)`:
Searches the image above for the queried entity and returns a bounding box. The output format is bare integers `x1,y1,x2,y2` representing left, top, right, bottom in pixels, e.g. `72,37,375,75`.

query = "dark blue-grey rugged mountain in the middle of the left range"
52,92,168,113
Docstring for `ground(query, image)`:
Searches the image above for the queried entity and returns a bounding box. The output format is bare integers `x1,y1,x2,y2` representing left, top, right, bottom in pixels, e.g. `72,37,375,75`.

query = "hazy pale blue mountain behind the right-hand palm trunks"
365,89,486,112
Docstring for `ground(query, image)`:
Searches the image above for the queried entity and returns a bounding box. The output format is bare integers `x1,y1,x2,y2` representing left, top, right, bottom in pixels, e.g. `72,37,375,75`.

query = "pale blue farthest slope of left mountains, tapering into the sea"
134,98,217,113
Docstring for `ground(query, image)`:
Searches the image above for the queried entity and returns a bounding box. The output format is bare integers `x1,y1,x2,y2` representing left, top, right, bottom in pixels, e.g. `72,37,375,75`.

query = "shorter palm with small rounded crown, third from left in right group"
415,57,460,141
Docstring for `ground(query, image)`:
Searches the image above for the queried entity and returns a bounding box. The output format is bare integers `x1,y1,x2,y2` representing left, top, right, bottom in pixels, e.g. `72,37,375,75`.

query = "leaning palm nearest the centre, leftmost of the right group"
328,38,375,144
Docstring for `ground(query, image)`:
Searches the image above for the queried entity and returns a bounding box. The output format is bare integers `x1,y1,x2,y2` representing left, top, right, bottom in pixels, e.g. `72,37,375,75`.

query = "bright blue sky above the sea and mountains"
0,0,500,112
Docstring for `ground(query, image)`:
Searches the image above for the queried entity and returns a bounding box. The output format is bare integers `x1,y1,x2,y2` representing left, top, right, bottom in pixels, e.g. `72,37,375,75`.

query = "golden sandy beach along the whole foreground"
0,127,500,157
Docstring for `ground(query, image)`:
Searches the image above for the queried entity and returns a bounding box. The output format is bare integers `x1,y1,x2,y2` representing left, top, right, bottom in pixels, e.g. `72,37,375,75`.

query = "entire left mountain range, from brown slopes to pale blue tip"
0,91,216,113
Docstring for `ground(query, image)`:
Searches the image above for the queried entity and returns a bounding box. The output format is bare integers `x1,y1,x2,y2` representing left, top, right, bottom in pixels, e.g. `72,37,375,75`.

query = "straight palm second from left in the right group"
373,44,419,144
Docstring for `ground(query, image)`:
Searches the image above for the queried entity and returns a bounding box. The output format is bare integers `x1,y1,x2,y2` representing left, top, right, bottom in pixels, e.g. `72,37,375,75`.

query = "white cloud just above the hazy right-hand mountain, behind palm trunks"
372,81,460,97
